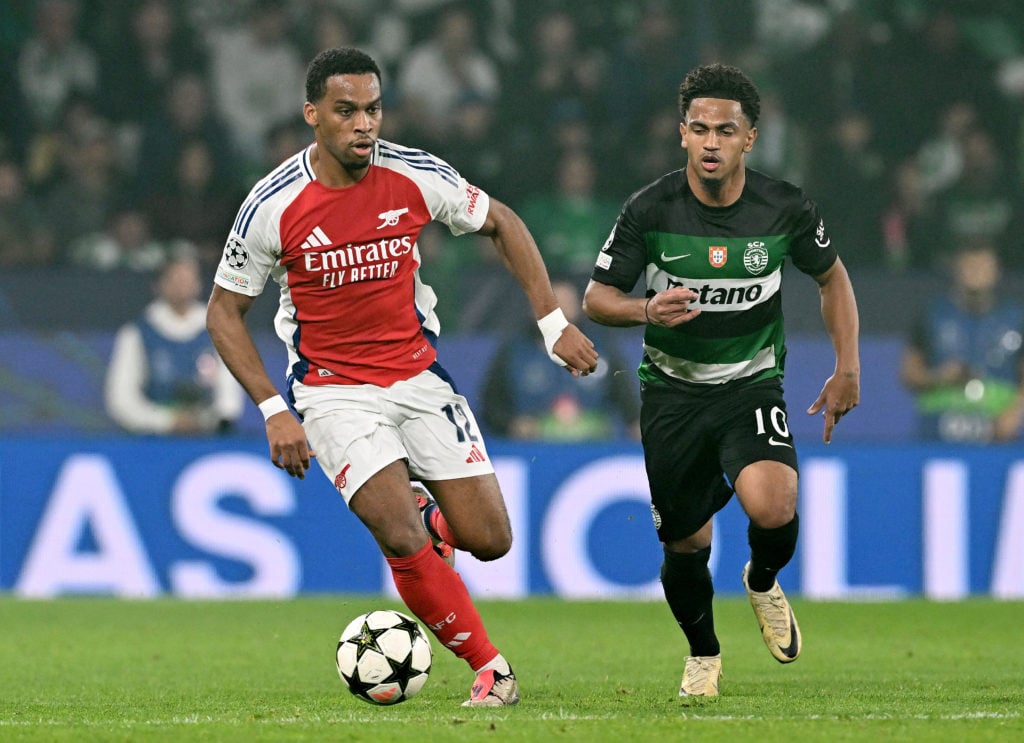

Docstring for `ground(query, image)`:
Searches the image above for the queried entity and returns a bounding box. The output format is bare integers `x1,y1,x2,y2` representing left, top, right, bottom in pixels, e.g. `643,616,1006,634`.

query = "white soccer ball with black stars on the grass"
336,609,433,704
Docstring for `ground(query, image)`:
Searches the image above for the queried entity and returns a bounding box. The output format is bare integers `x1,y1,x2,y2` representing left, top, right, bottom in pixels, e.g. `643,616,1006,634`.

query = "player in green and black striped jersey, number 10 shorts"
584,64,860,697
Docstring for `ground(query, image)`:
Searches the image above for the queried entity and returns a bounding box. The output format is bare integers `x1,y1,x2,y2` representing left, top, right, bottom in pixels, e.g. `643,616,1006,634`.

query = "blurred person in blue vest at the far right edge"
901,241,1024,443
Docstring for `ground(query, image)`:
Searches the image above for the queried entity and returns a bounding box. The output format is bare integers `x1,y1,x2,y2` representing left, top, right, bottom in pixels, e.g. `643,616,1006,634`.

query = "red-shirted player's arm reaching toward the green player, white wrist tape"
479,199,597,376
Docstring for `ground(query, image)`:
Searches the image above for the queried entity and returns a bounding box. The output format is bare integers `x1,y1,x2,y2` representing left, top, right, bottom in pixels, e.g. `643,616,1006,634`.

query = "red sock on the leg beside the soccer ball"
387,541,498,670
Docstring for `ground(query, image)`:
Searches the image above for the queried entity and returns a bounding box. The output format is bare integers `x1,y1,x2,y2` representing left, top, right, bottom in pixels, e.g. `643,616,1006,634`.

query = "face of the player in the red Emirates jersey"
303,74,381,179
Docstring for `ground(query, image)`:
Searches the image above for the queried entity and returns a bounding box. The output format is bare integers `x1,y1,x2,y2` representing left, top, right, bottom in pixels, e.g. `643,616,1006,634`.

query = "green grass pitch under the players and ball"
0,596,1024,743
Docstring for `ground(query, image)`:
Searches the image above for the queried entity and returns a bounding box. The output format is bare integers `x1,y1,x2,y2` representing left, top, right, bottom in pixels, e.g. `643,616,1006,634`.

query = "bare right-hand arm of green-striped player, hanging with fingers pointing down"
807,258,860,444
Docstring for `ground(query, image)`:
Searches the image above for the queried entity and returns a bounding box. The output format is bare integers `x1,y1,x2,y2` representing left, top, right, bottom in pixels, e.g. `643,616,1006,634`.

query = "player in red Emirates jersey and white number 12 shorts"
207,48,597,706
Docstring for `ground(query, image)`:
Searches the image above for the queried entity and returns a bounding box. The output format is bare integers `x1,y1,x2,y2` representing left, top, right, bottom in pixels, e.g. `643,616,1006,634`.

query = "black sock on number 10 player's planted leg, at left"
662,547,721,655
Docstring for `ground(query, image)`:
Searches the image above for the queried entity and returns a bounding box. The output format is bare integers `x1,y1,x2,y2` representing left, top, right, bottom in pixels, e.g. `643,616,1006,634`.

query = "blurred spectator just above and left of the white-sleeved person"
68,206,168,272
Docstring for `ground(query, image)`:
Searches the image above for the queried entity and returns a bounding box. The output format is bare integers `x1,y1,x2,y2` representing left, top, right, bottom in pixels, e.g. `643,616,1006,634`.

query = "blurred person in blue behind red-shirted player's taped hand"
481,278,640,441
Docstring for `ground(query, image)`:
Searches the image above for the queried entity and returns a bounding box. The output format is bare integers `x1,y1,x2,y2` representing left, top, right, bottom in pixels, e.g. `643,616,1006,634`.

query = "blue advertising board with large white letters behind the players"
0,438,1024,600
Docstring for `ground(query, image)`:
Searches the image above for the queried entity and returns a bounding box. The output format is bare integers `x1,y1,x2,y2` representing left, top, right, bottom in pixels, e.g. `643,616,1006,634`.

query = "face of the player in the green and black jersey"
679,98,758,185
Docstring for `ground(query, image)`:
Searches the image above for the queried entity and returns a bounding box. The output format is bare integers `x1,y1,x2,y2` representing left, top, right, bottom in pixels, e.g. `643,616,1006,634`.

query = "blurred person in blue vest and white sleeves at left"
105,254,244,435
